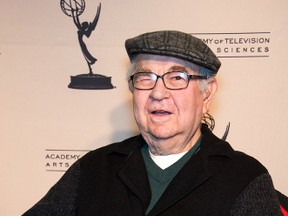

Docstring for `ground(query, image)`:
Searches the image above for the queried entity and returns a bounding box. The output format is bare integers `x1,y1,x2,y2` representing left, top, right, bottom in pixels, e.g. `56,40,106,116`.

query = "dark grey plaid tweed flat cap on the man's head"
125,31,221,74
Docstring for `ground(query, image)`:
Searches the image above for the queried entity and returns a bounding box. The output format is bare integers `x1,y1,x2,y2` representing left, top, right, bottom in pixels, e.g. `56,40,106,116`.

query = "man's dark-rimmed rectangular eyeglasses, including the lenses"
129,71,209,90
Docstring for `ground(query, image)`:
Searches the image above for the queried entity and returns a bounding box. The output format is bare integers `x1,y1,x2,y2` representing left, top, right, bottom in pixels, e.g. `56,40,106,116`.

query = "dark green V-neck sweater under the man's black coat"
142,138,201,214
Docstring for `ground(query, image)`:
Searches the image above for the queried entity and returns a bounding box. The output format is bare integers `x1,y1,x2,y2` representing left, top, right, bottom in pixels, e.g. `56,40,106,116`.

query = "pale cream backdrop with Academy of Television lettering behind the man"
0,0,288,216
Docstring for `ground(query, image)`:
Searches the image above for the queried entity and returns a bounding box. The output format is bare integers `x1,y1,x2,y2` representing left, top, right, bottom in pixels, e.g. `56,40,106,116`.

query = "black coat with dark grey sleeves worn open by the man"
25,125,280,216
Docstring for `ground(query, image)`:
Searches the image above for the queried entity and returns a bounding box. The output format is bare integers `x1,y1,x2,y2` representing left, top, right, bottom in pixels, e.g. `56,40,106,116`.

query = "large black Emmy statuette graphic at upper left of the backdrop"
60,0,114,89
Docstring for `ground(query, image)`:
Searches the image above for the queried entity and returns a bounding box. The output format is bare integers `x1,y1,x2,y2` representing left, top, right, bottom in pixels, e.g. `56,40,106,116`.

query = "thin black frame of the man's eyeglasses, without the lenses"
129,71,211,90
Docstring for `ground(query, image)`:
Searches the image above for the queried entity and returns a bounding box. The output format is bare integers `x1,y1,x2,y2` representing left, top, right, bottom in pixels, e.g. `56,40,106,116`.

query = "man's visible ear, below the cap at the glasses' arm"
203,77,218,114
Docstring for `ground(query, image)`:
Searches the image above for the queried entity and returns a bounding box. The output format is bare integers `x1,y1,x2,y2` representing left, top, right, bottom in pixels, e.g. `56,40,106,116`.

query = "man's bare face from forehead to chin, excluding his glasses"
133,54,217,154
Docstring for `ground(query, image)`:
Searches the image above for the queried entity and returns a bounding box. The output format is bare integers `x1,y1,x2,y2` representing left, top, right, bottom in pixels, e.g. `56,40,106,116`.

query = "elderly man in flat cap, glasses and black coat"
24,31,281,216
